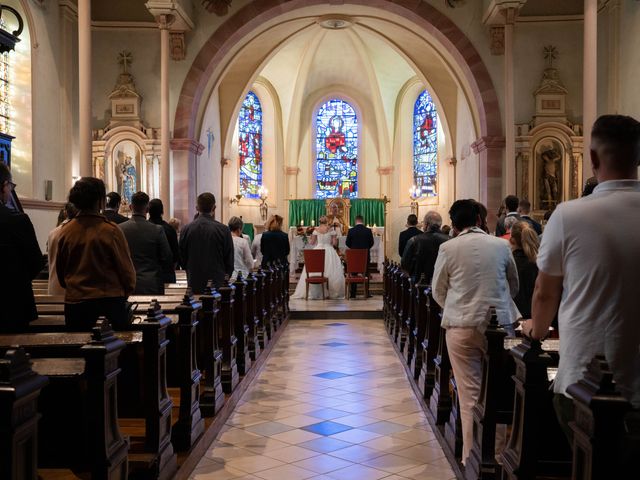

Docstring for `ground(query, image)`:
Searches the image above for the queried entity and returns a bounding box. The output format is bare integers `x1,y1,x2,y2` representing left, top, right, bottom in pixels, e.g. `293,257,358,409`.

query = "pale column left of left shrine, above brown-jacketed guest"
78,0,93,177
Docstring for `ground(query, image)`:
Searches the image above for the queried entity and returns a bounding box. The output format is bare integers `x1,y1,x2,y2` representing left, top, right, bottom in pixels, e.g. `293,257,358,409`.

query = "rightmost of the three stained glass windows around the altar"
413,90,438,197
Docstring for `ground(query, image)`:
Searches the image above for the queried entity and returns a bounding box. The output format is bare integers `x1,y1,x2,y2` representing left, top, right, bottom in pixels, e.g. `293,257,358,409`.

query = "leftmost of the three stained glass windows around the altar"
238,92,262,198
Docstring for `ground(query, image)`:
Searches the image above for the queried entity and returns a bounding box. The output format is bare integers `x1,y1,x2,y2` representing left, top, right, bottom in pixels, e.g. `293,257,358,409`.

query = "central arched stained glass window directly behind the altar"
316,99,358,198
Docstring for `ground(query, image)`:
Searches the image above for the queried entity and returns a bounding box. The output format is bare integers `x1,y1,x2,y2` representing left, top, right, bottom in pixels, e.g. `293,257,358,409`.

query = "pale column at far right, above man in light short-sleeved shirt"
582,0,598,181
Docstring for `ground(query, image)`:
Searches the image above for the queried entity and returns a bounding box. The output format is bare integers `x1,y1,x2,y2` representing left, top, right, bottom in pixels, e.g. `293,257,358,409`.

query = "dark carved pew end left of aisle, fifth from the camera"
198,280,224,417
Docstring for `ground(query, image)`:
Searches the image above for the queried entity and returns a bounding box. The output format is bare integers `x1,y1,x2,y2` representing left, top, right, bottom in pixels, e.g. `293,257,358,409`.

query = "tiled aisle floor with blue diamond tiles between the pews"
192,320,455,480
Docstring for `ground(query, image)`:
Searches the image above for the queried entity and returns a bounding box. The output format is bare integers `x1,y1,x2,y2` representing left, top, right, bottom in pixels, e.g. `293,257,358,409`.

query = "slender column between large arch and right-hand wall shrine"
502,8,517,195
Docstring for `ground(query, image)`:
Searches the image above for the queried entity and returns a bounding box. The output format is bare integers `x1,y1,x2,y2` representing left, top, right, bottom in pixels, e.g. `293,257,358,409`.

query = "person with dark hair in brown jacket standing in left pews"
56,177,136,331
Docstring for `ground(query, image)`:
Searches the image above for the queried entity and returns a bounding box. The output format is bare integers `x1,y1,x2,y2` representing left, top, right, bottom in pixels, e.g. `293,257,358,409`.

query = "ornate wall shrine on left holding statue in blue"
93,52,160,210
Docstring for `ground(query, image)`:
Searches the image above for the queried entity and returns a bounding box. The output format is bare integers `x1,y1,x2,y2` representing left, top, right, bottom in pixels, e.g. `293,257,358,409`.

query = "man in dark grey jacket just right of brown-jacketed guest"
118,192,173,295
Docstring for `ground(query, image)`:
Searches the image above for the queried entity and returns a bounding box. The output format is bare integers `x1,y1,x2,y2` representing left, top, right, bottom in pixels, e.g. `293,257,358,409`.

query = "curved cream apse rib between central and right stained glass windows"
346,28,391,166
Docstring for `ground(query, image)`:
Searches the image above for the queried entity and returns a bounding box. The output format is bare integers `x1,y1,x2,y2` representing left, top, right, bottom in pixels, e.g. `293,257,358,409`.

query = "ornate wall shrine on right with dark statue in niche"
516,46,583,218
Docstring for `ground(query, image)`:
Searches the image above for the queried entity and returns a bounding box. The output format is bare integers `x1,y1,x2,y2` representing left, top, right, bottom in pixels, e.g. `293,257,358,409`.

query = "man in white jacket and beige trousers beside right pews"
432,200,518,462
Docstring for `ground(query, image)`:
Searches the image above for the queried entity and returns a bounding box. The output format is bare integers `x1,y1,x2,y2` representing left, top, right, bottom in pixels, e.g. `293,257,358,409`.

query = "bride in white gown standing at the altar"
291,216,344,300
